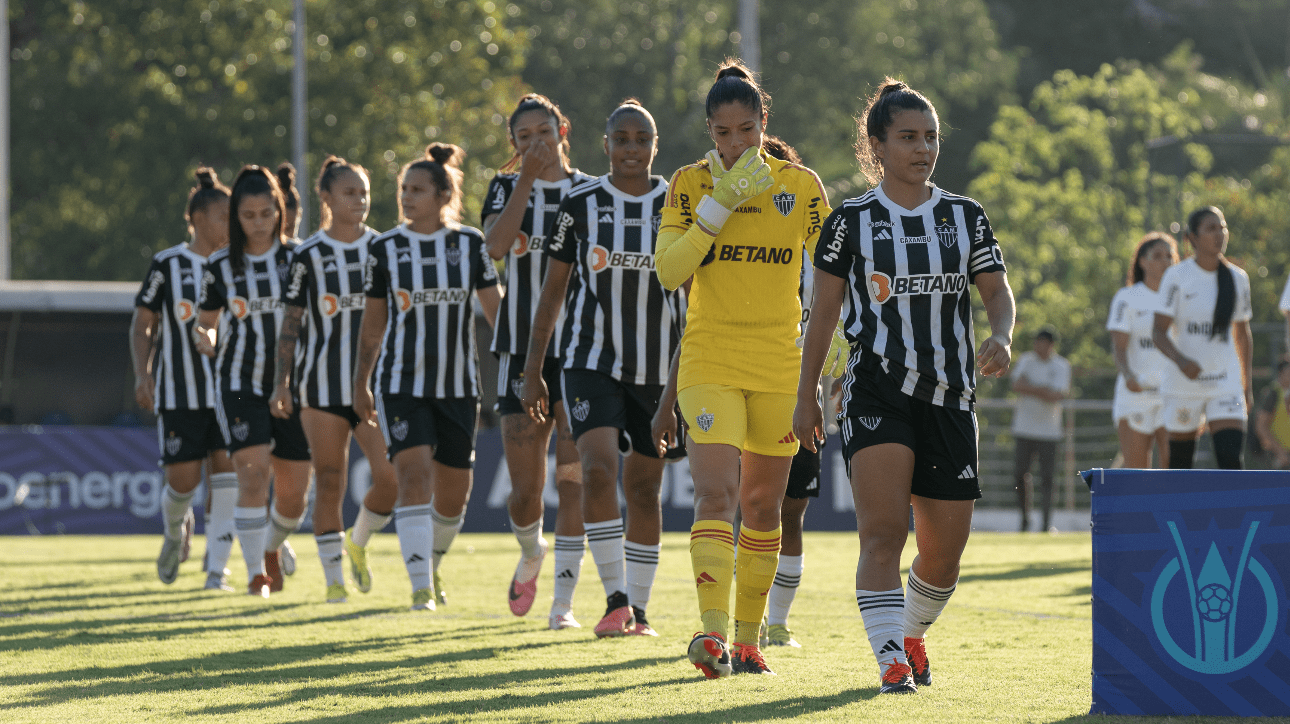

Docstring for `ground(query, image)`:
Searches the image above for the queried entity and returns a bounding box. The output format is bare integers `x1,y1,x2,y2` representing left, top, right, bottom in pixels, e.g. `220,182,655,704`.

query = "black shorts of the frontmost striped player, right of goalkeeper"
841,355,980,501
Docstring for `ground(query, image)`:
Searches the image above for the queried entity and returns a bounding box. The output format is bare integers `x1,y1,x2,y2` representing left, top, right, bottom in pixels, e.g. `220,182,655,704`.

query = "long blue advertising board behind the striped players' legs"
0,426,855,536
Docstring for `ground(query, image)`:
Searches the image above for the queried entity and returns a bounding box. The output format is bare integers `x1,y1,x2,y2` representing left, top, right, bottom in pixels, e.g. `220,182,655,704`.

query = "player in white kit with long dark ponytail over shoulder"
1152,206,1254,470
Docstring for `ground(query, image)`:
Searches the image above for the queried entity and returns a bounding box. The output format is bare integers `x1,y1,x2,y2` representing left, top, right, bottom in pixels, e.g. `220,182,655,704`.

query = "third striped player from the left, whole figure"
277,156,399,603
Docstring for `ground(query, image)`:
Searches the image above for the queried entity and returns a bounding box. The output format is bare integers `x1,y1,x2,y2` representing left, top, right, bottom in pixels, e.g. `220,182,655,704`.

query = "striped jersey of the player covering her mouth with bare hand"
480,169,593,356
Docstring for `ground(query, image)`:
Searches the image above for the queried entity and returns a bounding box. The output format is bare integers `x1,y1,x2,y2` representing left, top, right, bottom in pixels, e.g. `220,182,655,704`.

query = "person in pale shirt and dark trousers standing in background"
1011,327,1071,532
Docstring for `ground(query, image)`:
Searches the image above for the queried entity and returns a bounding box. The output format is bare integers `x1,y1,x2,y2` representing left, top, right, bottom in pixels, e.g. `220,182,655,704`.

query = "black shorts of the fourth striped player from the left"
377,395,480,470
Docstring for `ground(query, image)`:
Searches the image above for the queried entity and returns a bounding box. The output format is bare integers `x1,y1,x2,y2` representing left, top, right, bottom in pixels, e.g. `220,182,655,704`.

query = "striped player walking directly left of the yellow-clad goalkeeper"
522,98,680,638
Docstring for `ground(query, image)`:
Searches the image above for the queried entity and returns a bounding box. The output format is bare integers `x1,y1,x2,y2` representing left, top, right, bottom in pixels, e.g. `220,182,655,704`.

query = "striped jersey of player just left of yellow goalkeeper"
546,176,681,385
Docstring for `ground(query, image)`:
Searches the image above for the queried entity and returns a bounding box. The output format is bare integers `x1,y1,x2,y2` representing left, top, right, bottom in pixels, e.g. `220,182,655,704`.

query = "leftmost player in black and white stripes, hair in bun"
130,166,237,591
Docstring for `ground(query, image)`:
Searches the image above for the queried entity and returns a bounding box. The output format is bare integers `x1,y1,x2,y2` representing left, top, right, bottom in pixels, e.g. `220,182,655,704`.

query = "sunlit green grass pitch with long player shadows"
0,533,1248,724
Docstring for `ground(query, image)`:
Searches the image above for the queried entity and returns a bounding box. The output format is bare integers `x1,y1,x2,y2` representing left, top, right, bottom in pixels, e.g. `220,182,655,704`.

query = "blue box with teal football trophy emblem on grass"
1084,470,1290,716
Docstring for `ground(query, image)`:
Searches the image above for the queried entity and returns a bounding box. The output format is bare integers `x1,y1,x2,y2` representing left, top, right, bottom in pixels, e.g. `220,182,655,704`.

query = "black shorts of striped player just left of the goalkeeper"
564,369,663,458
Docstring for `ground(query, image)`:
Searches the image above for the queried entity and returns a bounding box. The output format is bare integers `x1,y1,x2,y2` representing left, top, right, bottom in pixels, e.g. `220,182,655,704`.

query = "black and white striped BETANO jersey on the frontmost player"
815,186,1005,416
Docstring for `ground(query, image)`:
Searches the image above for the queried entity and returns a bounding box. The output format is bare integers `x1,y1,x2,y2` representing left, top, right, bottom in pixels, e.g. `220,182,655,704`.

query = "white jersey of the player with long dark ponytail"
1156,258,1254,397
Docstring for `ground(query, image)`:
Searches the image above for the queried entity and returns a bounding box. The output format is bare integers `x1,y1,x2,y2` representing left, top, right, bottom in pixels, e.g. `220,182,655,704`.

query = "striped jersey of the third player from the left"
283,227,377,408
